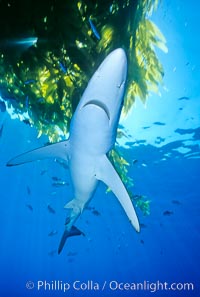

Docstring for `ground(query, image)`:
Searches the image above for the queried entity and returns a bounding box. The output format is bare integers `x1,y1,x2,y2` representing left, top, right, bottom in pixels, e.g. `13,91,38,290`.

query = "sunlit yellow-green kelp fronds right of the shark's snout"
123,1,168,116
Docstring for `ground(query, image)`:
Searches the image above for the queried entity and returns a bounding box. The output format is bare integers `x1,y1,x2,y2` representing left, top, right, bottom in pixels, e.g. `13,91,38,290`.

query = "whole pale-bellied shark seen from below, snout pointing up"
7,48,140,254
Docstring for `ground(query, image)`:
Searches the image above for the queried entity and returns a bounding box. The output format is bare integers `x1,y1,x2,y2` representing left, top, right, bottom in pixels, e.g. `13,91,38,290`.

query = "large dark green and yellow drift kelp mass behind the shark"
0,0,166,213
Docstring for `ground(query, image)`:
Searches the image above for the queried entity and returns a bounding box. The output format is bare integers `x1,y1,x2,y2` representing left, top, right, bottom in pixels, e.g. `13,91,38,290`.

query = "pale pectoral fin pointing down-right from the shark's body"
96,155,140,232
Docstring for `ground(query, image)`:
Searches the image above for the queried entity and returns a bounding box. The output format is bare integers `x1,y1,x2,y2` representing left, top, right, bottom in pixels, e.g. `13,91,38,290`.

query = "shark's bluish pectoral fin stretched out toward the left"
6,140,69,166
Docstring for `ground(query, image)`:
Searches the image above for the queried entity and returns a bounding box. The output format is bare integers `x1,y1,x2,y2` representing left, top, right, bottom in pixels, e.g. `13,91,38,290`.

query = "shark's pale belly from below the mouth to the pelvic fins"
69,104,119,203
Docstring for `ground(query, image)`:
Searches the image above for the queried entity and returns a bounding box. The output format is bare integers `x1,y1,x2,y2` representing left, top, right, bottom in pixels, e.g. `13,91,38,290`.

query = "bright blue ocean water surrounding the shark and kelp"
0,0,200,297
